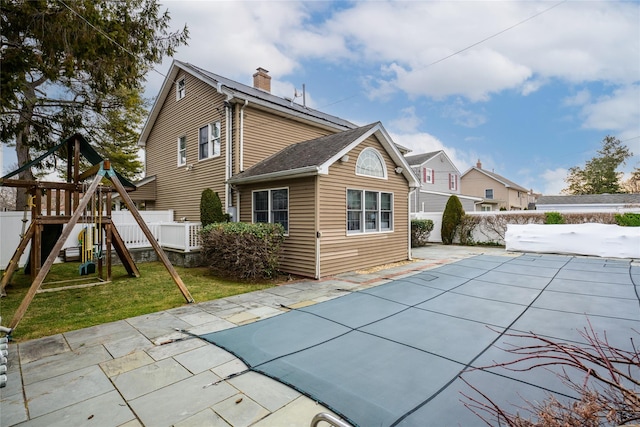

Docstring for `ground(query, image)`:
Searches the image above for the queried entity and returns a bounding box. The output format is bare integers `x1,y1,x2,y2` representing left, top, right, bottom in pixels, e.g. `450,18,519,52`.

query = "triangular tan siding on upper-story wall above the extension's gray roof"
243,108,335,170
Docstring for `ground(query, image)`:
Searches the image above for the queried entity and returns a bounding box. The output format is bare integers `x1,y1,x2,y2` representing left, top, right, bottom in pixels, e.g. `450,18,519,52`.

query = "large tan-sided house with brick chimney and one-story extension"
140,61,419,278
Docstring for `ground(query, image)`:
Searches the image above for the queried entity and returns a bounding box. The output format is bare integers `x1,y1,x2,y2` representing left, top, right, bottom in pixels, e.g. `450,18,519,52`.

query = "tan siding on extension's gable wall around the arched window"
319,137,409,276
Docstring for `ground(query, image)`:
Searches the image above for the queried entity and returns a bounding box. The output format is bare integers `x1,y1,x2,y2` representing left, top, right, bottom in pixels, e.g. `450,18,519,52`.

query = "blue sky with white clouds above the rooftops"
5,0,640,194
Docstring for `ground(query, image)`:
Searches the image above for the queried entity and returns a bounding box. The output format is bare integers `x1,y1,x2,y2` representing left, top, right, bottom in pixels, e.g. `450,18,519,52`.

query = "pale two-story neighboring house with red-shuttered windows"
405,150,482,213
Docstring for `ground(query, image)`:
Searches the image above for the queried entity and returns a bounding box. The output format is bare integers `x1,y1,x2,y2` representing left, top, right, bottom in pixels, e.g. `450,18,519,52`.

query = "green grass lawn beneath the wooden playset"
0,262,278,342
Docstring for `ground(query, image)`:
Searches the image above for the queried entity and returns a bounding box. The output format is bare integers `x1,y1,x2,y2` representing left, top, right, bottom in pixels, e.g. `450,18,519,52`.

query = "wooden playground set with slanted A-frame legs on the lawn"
0,134,193,336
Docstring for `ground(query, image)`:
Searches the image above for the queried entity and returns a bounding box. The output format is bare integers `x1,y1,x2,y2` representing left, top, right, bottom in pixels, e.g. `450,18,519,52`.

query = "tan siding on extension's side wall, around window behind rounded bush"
240,177,316,277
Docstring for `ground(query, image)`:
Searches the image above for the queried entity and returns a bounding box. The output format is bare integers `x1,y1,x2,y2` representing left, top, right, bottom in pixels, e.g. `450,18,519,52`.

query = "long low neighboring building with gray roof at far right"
536,194,640,212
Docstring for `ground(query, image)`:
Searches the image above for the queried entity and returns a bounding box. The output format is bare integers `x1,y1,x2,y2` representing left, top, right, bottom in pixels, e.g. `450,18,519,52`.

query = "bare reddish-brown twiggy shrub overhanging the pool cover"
462,323,640,427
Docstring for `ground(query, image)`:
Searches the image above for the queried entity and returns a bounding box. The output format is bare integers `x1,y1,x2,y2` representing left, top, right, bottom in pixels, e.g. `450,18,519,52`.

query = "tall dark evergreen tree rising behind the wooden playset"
0,0,188,206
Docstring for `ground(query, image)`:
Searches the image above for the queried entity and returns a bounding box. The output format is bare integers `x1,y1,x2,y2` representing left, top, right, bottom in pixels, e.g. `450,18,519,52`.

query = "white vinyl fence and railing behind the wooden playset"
0,210,202,269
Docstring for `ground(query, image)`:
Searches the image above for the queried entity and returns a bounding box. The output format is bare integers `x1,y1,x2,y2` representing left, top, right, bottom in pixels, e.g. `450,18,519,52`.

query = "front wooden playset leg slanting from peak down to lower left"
9,174,100,330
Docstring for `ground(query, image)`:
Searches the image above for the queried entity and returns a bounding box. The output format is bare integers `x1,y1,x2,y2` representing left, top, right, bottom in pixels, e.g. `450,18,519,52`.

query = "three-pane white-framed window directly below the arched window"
347,190,393,234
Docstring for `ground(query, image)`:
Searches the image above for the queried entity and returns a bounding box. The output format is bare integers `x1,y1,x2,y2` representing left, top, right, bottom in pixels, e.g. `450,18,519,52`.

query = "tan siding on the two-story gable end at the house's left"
146,72,227,221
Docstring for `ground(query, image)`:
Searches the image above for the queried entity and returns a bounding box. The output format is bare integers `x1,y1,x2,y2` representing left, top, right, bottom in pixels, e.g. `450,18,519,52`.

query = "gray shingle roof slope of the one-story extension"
229,122,379,183
